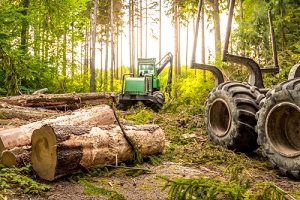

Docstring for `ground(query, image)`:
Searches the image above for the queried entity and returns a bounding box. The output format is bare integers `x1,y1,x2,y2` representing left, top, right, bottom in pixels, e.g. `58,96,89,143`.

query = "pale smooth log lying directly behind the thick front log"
0,105,115,154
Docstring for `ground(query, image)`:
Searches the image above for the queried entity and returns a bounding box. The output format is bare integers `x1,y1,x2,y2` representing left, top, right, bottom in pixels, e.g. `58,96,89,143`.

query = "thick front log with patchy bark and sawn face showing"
31,125,165,181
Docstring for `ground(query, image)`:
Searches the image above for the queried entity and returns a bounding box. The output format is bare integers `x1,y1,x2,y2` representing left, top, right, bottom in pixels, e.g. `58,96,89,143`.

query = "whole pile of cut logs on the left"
0,93,165,181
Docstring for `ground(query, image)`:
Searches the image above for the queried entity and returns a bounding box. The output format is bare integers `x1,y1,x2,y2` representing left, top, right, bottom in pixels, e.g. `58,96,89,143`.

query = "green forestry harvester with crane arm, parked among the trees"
117,53,173,112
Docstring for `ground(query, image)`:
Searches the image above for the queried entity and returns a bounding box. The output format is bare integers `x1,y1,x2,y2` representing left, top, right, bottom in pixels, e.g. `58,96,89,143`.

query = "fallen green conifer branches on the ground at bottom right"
160,162,295,200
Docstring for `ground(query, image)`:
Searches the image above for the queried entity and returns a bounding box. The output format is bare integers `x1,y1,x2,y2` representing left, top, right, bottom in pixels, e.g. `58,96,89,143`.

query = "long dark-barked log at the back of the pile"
0,92,115,110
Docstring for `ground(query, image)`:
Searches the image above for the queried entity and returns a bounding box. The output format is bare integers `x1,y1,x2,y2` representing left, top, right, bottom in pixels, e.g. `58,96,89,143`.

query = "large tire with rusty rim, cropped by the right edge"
257,78,300,179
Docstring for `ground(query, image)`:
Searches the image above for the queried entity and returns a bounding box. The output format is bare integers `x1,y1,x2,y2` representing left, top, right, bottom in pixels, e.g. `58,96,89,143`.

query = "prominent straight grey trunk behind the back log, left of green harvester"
90,0,98,92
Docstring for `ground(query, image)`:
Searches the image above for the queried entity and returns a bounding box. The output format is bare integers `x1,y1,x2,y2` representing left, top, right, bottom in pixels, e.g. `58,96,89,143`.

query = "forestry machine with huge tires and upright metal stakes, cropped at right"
191,0,300,179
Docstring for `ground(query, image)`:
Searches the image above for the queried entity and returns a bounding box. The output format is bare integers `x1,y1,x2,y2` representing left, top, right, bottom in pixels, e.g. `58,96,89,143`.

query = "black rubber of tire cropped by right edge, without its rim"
257,78,300,179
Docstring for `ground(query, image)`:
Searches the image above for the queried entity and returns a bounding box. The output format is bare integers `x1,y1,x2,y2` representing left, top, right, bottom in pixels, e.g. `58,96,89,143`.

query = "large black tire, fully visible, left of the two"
205,81,264,152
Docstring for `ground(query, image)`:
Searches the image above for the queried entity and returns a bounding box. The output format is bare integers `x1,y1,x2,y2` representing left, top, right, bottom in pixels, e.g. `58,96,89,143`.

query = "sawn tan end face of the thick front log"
31,125,57,181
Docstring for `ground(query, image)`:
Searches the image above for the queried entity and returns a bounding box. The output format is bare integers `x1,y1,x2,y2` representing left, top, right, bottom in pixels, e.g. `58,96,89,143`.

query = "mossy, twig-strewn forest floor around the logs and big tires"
0,105,300,200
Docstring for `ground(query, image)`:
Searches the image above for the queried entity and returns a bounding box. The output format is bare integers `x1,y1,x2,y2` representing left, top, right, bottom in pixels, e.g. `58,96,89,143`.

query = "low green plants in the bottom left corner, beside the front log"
0,165,50,197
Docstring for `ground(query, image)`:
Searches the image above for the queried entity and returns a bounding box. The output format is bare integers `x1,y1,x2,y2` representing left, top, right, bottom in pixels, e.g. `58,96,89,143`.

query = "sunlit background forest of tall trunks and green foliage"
0,0,300,96
